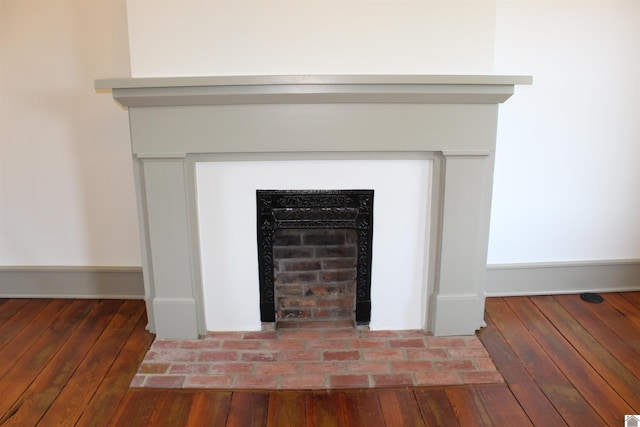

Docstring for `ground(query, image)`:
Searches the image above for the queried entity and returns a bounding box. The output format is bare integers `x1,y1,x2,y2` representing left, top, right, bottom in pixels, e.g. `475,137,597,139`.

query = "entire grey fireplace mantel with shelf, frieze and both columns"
96,75,531,338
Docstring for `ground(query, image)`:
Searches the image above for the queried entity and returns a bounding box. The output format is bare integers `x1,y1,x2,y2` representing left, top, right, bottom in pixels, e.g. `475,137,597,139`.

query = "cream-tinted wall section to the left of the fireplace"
0,0,140,266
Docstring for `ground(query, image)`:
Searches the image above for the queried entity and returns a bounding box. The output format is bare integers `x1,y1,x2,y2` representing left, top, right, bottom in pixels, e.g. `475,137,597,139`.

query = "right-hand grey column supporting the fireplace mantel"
432,153,493,336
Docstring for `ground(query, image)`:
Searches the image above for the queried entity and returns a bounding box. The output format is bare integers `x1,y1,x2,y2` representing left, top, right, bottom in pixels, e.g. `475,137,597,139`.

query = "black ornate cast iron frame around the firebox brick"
256,190,373,325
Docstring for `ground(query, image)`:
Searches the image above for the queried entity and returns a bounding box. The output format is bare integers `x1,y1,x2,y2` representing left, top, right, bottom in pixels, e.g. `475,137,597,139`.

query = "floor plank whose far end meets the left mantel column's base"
76,316,153,427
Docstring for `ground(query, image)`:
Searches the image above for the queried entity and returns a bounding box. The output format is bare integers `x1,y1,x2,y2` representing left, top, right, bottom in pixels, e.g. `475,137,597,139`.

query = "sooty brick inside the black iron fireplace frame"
273,229,358,327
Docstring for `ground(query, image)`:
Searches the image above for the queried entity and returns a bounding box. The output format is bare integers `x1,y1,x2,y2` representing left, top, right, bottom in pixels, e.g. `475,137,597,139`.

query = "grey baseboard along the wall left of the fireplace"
0,266,144,299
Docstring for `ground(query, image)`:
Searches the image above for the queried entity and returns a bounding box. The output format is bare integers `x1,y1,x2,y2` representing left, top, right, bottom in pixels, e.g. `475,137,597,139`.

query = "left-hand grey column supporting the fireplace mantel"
137,158,205,338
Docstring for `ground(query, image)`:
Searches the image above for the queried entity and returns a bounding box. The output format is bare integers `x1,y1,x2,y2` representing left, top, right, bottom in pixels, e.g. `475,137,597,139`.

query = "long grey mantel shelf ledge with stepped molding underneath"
95,75,532,107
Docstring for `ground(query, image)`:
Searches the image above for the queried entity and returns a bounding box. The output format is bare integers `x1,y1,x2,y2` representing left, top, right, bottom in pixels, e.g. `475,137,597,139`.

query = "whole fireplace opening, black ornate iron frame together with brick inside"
256,190,374,325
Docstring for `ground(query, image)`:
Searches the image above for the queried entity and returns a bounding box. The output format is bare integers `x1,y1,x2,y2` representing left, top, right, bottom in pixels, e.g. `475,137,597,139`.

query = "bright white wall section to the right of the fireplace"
489,0,640,263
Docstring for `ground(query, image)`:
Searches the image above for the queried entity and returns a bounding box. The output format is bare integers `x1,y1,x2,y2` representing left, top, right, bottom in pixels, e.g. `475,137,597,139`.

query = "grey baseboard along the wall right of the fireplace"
485,260,640,296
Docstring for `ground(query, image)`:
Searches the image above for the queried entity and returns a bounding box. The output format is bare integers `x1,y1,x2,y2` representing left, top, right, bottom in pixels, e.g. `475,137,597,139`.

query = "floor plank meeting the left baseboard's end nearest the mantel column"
41,300,144,425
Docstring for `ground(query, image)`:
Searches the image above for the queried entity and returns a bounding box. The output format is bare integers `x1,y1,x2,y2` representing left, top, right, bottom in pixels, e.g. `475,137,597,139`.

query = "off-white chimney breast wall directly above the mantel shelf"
127,0,495,77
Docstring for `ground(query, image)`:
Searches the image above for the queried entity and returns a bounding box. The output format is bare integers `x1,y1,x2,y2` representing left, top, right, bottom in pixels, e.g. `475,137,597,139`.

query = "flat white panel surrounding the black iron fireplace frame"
196,159,433,331
